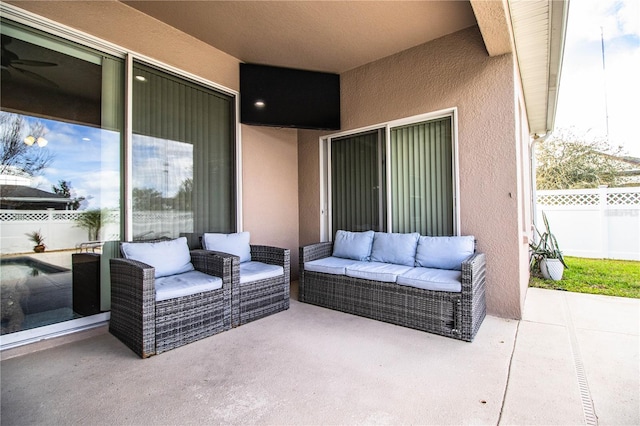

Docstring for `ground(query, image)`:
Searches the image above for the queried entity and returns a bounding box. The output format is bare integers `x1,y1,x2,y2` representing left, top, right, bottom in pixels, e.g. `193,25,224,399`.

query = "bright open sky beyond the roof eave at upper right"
555,0,640,158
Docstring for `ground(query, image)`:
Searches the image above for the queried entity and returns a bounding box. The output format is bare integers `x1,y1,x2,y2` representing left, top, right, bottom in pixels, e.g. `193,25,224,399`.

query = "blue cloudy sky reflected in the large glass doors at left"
24,117,193,210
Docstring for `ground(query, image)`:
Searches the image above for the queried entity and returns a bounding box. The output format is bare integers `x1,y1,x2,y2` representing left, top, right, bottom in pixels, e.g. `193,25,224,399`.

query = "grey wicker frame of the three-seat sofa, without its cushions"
299,242,486,342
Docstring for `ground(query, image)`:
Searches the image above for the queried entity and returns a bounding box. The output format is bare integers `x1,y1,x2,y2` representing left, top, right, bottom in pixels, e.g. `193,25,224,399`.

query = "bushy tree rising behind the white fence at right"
536,130,624,189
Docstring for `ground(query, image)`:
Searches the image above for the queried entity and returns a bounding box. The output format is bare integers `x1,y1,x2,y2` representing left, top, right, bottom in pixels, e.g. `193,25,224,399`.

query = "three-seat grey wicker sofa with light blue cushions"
299,231,486,342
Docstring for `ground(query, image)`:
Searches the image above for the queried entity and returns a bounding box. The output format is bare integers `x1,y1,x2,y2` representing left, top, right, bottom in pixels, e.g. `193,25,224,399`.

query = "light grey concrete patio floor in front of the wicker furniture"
0,288,640,425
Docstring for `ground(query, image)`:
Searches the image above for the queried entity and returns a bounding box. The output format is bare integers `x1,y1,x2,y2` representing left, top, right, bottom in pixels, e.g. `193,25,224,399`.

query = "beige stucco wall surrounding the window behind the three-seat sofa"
299,27,526,318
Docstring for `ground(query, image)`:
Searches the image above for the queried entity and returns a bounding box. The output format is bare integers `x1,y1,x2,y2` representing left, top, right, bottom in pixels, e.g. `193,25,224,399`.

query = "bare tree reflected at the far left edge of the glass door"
0,112,53,176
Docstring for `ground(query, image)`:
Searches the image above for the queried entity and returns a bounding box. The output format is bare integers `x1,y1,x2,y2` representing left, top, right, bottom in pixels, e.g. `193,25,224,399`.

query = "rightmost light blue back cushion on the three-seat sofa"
416,235,475,271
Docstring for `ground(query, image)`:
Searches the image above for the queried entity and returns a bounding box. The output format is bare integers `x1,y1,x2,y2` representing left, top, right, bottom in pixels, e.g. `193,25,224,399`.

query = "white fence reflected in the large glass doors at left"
0,210,193,254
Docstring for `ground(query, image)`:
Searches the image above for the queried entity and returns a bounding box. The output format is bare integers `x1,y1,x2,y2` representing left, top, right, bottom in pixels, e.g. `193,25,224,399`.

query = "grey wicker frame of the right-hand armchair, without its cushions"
231,244,291,327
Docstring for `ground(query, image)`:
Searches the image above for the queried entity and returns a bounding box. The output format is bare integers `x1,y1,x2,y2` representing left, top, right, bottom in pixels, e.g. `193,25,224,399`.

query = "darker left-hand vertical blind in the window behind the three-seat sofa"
331,131,384,235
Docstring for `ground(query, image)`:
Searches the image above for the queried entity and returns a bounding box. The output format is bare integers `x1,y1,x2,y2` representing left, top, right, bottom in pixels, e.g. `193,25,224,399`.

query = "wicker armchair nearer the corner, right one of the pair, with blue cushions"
199,232,291,327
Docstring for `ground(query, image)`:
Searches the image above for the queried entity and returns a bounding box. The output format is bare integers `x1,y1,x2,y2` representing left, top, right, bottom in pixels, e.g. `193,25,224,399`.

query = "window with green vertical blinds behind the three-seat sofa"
323,111,459,238
